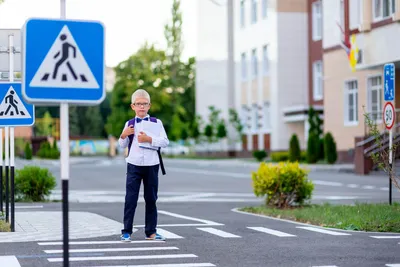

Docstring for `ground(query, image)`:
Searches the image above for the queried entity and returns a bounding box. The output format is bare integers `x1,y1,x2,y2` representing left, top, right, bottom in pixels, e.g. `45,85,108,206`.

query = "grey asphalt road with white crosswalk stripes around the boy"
0,159,400,267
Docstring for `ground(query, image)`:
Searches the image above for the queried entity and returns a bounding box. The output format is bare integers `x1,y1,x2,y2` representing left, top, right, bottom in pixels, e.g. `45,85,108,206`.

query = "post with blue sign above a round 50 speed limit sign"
383,63,396,205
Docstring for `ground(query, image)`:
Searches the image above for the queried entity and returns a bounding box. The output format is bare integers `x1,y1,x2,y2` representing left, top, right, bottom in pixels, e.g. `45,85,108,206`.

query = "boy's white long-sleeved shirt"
118,115,169,166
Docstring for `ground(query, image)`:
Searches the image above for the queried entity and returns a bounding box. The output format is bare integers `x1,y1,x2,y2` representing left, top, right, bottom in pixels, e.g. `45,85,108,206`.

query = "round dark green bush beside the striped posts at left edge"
15,166,56,201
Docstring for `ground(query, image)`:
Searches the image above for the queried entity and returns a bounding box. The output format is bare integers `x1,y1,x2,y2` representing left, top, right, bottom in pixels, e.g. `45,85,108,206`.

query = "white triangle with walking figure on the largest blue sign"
29,25,100,89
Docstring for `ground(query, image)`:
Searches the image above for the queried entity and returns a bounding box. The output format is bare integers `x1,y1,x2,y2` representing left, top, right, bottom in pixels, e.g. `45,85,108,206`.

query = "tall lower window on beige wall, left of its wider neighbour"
344,81,358,124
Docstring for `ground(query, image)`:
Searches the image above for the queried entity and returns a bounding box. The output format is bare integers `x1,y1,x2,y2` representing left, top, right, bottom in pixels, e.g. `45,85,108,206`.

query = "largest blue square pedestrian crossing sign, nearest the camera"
22,19,105,104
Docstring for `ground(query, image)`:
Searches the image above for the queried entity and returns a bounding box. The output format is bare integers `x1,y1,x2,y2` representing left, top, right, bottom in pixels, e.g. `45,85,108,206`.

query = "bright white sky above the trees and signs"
0,0,197,67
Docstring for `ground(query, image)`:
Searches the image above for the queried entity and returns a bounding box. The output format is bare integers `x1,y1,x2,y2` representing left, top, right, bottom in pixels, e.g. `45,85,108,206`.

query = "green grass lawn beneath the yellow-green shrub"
240,203,400,233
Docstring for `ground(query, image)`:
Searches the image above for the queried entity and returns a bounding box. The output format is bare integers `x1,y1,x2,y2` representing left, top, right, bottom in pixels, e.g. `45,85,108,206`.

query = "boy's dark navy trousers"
122,163,159,236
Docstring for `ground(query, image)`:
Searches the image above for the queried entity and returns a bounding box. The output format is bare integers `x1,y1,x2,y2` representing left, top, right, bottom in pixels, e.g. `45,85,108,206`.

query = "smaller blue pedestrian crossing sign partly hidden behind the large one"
0,83,35,127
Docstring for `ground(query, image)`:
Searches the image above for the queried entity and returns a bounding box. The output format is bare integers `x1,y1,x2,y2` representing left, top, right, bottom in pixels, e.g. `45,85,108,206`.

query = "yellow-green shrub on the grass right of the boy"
252,162,314,208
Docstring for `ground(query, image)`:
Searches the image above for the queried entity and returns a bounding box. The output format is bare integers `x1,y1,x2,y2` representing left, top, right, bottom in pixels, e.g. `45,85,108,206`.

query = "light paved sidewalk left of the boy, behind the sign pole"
0,211,123,243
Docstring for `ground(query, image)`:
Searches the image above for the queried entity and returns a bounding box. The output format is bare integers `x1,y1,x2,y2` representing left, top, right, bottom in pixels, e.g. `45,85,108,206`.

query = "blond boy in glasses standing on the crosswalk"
118,89,169,242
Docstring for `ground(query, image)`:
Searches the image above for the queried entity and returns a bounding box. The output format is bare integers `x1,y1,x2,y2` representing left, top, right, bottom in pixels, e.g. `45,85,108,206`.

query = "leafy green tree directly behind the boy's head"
106,43,172,137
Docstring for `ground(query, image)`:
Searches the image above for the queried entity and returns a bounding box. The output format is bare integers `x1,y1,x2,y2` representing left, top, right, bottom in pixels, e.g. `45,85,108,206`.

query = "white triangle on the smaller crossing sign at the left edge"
0,86,32,120
